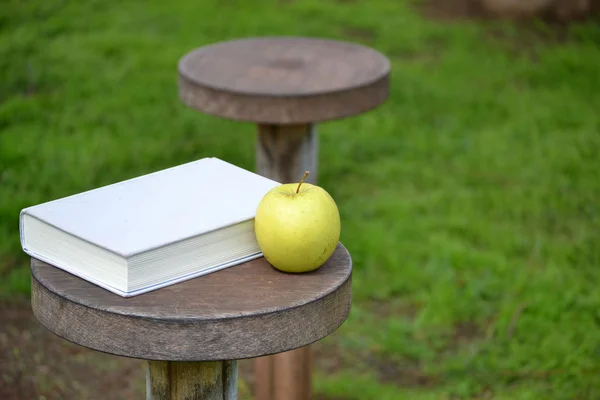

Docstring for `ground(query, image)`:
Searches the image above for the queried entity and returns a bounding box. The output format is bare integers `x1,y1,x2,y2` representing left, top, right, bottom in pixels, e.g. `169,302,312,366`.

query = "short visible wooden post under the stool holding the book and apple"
146,361,237,400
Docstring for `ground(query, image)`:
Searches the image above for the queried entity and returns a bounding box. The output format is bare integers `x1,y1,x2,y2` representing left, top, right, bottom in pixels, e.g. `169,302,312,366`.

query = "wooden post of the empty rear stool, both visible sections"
254,124,318,400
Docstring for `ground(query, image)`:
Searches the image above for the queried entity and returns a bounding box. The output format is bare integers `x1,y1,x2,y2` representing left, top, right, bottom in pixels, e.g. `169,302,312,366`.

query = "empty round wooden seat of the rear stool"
179,37,390,124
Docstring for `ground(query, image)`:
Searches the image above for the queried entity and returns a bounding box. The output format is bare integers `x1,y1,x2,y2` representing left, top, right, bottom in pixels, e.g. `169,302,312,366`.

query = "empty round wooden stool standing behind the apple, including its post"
179,37,390,400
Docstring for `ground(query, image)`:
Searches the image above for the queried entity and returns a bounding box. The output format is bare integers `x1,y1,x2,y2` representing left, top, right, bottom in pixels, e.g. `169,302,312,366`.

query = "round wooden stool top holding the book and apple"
31,244,352,361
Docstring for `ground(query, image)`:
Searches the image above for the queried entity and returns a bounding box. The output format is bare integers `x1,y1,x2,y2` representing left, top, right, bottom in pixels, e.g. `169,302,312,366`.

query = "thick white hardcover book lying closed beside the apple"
19,157,280,297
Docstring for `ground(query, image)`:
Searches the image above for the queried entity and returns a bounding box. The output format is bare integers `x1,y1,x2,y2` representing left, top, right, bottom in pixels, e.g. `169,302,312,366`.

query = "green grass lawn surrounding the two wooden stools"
0,0,600,400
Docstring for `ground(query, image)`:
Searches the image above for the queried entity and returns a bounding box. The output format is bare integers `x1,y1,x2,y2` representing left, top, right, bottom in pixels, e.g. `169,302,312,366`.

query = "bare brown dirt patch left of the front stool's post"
0,301,145,400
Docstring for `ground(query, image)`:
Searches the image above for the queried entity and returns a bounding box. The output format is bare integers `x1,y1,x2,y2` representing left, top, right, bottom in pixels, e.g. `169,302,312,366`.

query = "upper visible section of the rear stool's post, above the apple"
256,125,318,184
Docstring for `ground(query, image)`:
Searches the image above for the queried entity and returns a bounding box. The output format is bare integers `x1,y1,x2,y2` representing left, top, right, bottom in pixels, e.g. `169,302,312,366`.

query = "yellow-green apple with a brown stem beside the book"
254,171,341,273
